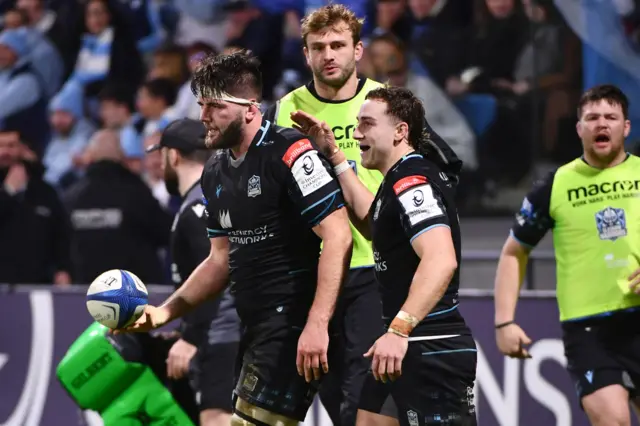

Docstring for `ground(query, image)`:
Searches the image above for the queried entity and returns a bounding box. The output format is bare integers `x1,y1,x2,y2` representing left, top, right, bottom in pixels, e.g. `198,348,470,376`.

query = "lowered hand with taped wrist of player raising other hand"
364,333,409,383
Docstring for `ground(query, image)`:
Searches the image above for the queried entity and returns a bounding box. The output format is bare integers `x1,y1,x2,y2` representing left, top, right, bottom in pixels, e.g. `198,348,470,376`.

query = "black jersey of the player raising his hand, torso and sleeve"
369,153,469,337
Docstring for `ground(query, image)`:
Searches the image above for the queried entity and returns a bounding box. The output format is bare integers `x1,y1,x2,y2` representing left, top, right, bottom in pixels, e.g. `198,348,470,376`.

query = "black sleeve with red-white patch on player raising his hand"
393,174,450,242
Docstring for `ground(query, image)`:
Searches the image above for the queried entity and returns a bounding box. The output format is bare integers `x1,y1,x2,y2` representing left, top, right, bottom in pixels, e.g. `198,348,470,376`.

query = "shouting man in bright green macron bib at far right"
495,85,640,426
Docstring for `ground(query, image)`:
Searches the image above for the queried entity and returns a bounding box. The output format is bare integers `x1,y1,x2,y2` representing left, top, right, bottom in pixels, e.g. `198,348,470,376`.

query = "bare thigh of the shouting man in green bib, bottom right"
580,384,631,426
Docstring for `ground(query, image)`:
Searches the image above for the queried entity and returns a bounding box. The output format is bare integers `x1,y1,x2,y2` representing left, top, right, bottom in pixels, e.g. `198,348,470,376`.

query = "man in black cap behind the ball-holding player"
147,119,240,426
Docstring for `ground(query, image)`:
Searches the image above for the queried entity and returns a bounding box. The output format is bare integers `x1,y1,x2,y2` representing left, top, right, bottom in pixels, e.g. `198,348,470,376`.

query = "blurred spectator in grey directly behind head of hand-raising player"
368,34,478,171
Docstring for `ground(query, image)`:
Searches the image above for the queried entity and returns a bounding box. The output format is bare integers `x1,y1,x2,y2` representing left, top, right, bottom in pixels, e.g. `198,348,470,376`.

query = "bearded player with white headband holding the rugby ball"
118,53,353,426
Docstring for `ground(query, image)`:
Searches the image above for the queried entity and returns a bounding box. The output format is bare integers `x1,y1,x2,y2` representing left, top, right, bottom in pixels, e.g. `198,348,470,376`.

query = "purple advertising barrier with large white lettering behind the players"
0,272,608,426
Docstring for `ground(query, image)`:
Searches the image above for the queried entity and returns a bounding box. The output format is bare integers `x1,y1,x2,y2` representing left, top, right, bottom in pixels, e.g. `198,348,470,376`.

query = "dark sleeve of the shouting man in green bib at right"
511,172,555,248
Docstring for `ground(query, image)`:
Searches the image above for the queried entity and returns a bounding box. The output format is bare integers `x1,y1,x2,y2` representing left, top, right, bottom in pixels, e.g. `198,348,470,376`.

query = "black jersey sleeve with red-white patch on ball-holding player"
281,139,345,227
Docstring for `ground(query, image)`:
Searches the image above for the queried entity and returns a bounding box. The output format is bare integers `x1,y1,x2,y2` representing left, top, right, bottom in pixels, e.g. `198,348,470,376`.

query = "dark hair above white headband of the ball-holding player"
191,51,262,101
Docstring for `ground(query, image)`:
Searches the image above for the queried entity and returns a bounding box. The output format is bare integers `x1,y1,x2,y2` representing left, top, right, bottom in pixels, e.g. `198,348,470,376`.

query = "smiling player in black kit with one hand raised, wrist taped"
292,88,476,426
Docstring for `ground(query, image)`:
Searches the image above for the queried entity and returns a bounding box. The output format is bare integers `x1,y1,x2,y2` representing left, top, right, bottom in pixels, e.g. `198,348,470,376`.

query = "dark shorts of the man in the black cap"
192,342,239,416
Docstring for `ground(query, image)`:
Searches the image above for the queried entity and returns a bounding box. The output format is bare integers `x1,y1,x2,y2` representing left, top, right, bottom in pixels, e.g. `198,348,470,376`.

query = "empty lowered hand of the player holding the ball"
296,323,329,383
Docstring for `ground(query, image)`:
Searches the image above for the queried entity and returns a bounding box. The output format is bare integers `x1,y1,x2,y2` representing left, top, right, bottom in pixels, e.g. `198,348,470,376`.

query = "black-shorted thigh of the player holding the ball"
235,318,320,421
